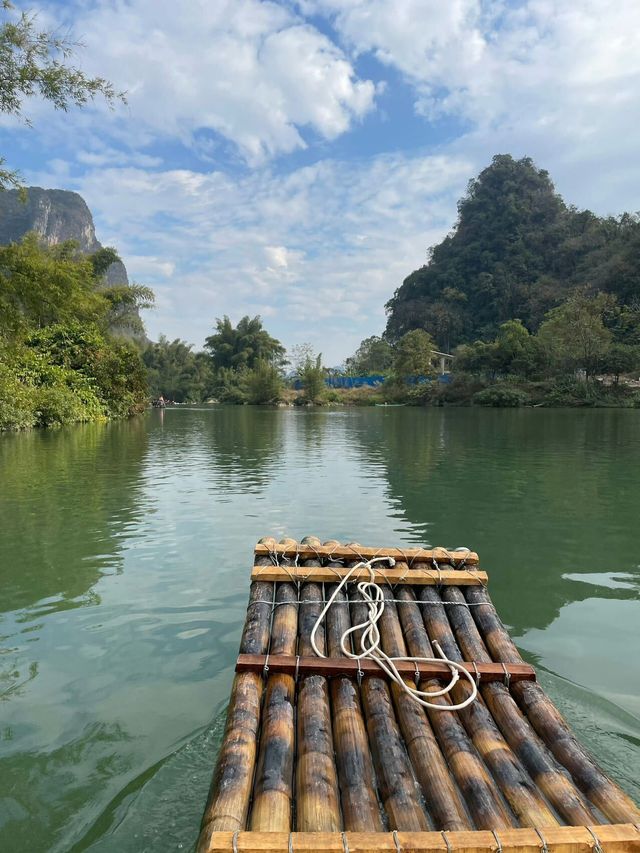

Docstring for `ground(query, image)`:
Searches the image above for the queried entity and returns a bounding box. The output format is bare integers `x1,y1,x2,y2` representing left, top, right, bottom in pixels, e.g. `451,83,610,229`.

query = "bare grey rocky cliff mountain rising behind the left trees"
0,187,129,285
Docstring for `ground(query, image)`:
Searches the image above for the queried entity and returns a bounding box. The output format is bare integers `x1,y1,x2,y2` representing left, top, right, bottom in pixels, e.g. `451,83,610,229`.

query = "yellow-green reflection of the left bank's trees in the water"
0,420,146,611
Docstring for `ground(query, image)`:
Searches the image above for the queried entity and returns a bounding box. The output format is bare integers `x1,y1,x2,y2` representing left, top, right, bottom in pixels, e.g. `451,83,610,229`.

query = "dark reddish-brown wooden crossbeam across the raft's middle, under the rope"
236,655,536,682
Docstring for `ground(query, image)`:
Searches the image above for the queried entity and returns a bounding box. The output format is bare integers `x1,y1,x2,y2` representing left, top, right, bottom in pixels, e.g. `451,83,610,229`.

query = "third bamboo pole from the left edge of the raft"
296,536,342,832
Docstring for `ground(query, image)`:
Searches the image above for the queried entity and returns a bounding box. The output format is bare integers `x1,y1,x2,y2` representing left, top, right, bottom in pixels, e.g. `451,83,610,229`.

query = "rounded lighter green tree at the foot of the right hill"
538,288,615,381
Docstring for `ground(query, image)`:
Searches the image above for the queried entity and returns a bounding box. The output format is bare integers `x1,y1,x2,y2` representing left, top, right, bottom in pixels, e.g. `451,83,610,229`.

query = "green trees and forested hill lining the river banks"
0,155,640,430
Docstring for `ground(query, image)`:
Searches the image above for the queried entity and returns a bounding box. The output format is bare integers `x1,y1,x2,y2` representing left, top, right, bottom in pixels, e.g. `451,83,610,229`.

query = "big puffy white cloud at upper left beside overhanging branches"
51,0,375,164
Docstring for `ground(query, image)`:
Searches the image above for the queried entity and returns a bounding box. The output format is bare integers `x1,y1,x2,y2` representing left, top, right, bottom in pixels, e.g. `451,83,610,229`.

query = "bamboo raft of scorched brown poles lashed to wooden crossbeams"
197,537,640,853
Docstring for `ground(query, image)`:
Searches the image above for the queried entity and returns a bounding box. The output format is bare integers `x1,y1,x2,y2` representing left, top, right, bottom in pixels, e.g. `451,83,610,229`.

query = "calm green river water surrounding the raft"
0,408,640,853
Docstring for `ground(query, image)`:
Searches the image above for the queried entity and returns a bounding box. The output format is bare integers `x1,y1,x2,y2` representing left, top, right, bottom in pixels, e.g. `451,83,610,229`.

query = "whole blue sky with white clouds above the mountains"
0,0,640,365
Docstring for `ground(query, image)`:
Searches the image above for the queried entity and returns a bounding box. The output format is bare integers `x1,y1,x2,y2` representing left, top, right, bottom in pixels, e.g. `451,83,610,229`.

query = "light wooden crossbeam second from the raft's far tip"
251,564,488,586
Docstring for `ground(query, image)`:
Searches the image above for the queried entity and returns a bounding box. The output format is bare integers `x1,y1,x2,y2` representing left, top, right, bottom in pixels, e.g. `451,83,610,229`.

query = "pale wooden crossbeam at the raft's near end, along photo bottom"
205,823,640,853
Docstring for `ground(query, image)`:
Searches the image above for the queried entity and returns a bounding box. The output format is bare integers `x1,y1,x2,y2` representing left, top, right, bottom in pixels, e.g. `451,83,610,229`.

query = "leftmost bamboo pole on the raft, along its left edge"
198,539,273,850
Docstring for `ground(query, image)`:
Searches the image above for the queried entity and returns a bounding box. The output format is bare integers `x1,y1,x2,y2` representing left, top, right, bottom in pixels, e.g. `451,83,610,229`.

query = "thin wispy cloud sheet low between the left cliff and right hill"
33,155,472,363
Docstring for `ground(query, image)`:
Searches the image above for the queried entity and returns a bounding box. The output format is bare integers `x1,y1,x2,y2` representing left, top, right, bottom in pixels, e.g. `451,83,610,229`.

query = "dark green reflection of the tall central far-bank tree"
198,406,284,492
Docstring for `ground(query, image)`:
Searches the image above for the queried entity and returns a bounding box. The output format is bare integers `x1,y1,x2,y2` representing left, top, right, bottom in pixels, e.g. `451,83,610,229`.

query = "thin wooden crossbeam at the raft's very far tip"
255,543,479,566
